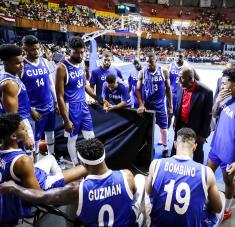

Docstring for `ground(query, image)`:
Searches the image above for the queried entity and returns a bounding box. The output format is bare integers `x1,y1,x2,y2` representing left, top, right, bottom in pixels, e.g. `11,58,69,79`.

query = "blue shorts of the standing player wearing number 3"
145,104,168,129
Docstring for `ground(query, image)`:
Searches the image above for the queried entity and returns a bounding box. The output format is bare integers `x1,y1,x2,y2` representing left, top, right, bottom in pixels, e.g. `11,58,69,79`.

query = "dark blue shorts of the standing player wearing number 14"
35,110,56,141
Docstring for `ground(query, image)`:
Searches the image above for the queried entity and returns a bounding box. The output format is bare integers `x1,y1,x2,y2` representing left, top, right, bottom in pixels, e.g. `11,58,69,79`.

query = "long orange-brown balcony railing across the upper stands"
0,18,235,42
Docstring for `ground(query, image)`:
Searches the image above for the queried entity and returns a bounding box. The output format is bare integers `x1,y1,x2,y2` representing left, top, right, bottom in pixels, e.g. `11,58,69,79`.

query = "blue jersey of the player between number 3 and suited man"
169,61,183,94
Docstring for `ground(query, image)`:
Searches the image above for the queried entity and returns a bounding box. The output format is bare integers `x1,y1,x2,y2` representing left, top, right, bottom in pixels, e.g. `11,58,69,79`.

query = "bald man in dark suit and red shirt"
172,66,213,163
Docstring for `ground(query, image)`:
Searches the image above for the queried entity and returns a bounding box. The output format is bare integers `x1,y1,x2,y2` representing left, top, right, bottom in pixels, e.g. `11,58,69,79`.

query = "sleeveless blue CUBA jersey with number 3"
143,66,166,110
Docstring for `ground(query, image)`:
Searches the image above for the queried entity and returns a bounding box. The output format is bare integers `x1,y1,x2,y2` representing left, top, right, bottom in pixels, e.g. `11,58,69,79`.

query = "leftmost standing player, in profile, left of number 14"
0,44,34,154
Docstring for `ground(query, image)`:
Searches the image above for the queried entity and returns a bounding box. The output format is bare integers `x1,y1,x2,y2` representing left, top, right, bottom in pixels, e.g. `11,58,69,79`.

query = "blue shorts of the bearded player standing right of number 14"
64,102,93,137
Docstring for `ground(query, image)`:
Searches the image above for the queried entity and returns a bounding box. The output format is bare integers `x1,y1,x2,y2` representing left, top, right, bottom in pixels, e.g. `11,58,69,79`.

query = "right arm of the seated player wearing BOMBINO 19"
206,167,222,213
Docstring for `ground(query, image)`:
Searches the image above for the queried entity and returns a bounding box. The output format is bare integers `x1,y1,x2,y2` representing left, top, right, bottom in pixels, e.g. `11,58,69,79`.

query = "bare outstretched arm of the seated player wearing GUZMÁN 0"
0,181,79,205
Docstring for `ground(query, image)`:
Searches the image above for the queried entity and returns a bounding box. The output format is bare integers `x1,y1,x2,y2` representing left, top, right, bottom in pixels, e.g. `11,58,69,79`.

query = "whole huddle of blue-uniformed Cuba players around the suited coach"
0,35,235,227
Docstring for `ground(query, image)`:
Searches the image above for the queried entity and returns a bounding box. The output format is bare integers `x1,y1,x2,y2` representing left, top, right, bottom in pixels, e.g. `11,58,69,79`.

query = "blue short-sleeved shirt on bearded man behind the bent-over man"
90,66,123,98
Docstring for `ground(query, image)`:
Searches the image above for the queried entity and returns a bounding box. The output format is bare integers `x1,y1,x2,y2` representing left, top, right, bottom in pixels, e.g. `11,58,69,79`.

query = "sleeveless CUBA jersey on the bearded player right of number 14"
61,59,86,103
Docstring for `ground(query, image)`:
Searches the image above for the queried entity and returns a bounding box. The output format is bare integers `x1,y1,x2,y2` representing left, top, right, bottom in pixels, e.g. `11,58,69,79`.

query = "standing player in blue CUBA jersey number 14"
22,35,58,160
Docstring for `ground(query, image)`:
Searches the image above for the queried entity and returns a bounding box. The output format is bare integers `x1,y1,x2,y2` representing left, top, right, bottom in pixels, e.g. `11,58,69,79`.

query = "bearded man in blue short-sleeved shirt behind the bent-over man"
90,51,124,98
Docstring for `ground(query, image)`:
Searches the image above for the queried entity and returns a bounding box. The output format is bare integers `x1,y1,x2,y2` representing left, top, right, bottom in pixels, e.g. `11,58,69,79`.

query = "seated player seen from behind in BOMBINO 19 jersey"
145,128,222,227
